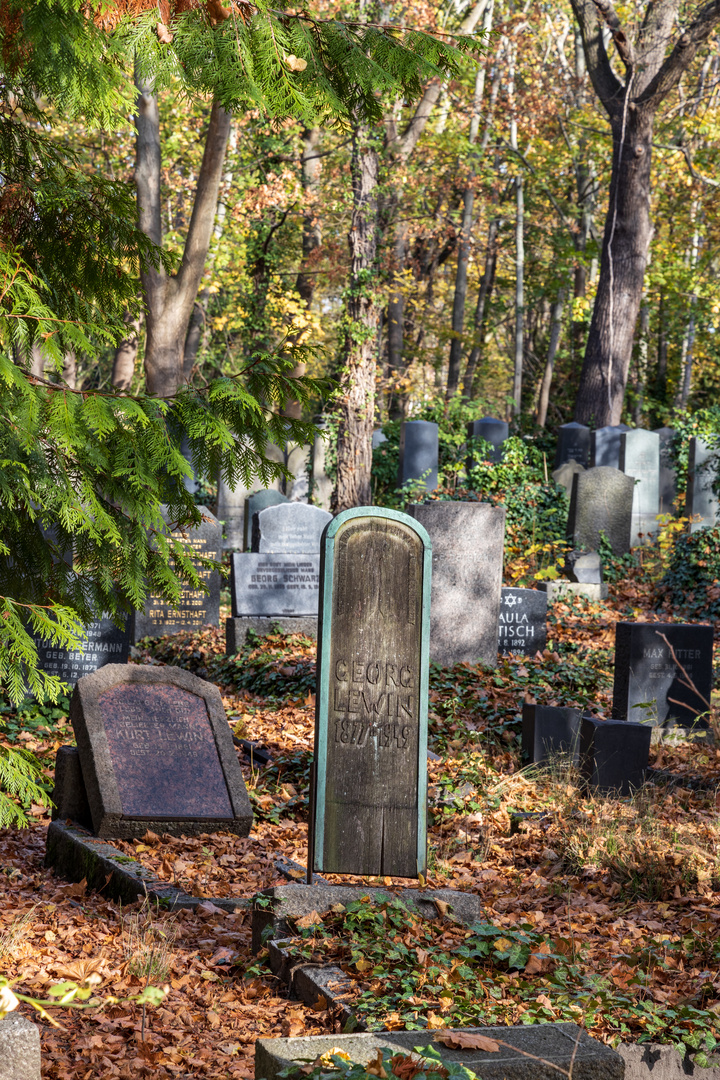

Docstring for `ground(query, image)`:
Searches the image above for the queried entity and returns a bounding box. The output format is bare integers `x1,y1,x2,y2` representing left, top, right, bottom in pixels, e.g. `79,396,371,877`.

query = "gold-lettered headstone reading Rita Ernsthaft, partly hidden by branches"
130,507,222,644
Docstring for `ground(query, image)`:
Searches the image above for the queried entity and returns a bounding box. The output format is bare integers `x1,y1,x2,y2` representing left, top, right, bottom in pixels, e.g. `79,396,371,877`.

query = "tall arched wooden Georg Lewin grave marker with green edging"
309,507,431,878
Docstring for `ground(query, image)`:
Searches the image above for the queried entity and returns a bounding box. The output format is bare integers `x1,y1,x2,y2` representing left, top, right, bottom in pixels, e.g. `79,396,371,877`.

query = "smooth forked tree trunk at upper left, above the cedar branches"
135,72,230,397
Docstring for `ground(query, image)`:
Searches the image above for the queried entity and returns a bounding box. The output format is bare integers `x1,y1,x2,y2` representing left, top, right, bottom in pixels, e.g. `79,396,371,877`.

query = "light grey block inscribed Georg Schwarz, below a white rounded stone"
230,552,320,618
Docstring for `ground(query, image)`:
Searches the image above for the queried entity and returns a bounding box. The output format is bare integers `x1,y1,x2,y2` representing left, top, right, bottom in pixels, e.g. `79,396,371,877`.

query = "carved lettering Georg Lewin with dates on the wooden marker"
332,660,417,750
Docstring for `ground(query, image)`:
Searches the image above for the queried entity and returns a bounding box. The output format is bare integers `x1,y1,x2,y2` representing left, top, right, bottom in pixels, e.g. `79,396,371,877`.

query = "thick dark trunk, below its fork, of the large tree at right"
574,108,653,428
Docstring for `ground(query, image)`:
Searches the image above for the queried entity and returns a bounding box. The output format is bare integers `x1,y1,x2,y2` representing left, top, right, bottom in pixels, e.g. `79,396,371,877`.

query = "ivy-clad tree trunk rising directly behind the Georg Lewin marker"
331,124,379,513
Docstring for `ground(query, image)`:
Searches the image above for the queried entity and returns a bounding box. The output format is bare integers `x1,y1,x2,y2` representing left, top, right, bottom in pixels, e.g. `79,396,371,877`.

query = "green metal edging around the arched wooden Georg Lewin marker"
308,507,433,875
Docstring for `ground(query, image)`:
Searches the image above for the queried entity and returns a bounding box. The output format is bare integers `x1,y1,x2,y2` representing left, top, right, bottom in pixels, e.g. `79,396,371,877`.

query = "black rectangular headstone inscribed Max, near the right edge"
612,622,712,728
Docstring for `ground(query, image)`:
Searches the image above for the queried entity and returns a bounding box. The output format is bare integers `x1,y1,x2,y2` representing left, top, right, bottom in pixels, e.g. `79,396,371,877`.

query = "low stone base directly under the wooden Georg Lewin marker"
253,885,480,951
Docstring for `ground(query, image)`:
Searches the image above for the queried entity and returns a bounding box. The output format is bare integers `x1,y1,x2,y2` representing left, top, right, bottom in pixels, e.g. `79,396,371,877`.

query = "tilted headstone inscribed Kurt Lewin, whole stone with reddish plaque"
70,664,253,838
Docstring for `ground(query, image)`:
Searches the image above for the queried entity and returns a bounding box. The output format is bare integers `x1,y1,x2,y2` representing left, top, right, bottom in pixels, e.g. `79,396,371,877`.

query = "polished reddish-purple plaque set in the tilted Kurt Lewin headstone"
99,684,233,819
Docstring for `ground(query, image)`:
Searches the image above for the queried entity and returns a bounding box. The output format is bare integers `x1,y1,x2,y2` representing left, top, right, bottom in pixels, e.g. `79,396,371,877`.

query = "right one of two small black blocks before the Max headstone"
580,716,652,795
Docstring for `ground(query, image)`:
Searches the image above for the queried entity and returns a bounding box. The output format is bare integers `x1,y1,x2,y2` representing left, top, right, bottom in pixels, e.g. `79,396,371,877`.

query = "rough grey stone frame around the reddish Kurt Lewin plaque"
70,664,253,839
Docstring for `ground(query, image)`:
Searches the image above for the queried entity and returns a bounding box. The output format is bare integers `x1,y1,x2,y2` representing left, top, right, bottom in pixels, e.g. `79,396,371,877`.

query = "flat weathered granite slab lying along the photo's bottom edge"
255,1024,625,1080
